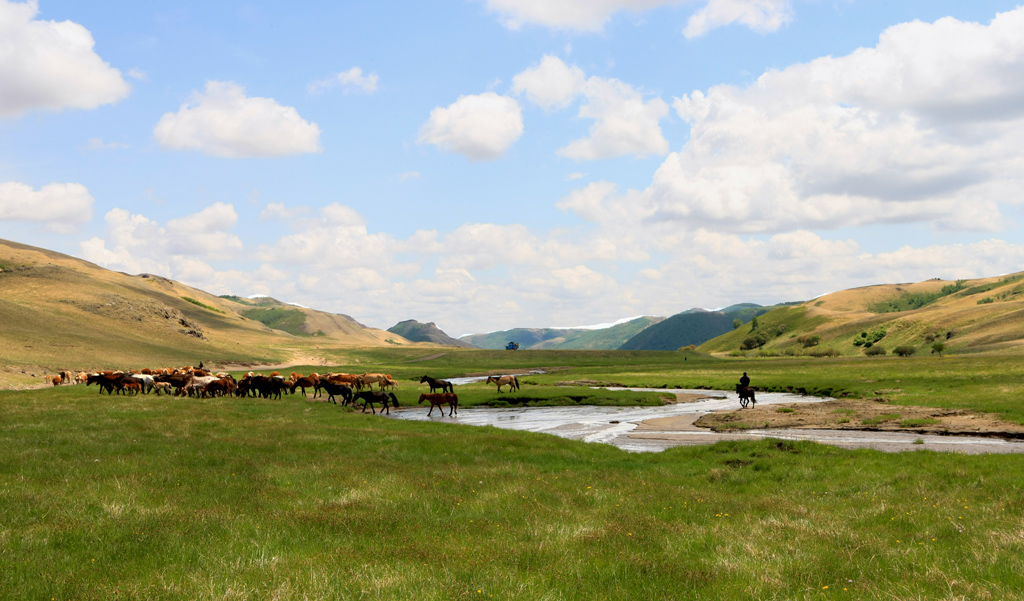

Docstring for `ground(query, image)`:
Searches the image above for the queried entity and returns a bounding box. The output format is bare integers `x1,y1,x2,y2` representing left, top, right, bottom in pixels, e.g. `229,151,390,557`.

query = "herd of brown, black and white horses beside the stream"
46,367,519,416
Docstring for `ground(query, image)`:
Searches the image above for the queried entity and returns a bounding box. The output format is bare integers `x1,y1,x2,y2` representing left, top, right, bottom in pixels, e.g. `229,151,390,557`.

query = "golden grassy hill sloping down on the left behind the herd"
0,241,430,386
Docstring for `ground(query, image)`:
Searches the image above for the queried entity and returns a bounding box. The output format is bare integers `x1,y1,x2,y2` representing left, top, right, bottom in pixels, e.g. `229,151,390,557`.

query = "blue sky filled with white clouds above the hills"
0,0,1024,336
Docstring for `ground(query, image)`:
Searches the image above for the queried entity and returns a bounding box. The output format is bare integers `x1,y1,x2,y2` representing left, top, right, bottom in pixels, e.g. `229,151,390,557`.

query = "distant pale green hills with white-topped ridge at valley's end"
460,316,664,350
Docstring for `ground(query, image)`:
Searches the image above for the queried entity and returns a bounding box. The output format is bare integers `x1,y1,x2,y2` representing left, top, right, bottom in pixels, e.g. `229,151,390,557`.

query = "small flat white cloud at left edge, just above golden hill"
0,181,94,231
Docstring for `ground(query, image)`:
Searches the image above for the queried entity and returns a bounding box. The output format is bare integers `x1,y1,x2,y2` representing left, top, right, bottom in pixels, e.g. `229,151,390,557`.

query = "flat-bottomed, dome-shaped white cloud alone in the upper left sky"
153,81,321,158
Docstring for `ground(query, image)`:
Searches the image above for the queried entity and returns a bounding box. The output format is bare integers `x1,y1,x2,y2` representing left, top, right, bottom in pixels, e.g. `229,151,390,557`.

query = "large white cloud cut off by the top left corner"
0,0,131,117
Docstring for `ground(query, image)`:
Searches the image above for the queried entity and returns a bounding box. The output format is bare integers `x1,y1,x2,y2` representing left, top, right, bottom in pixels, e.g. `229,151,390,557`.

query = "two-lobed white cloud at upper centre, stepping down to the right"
512,54,669,161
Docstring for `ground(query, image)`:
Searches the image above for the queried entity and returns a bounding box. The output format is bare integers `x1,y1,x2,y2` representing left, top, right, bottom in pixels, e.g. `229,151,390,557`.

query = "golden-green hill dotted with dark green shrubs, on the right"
700,272,1024,355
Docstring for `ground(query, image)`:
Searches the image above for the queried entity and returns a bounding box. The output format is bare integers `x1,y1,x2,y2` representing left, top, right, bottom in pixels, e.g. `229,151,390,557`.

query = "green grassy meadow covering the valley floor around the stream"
0,349,1024,600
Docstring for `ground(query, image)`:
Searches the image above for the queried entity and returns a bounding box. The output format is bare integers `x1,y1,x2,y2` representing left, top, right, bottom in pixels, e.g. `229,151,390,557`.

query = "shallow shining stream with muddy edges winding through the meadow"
391,388,1024,454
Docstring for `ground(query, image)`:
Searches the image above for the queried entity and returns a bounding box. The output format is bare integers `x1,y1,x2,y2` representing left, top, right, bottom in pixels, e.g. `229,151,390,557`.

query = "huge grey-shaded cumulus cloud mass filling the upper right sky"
630,8,1024,231
